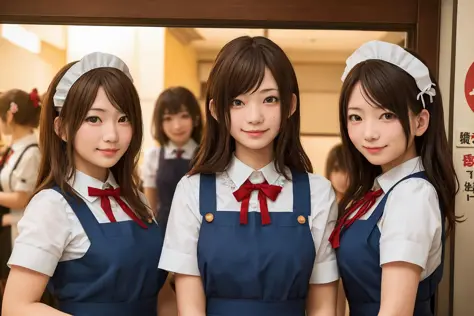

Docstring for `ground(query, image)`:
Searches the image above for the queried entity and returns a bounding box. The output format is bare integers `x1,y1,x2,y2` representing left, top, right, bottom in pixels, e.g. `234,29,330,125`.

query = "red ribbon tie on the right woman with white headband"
329,189,383,249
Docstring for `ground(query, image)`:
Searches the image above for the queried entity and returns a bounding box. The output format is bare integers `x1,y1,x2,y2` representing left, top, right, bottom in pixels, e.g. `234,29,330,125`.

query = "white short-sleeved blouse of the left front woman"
8,171,152,276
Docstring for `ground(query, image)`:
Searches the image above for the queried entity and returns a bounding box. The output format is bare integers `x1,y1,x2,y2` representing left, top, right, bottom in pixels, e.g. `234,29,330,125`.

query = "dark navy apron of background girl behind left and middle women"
156,148,191,236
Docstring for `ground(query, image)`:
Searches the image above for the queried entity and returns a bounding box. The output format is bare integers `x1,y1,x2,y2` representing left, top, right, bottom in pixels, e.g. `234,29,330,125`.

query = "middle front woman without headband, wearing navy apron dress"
160,37,339,316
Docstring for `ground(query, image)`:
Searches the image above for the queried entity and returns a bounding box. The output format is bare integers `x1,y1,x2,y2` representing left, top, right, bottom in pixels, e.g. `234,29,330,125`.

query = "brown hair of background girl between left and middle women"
151,87,202,146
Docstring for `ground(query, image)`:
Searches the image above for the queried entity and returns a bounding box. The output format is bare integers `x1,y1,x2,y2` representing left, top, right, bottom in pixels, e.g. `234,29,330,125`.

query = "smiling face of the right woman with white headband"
347,83,416,172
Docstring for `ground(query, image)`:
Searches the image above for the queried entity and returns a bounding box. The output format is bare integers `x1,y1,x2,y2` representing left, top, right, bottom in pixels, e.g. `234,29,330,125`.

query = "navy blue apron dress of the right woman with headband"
337,172,445,316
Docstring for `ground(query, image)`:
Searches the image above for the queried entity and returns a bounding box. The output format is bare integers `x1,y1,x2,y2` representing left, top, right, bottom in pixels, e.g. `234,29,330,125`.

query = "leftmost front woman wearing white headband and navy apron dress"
3,53,176,316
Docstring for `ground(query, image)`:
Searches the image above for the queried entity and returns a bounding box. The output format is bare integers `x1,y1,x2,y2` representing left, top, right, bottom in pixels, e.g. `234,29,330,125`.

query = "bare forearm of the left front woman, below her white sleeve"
2,266,68,316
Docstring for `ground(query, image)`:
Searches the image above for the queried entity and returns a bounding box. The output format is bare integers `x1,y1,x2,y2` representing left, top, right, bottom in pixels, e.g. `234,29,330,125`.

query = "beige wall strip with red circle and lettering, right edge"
452,0,474,316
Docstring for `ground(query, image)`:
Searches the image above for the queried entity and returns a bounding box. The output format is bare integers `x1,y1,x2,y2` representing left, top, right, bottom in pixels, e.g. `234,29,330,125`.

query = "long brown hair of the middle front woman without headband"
189,36,313,178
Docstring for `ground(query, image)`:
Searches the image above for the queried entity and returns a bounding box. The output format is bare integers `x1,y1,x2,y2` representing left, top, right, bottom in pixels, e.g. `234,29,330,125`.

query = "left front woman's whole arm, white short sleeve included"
2,189,71,316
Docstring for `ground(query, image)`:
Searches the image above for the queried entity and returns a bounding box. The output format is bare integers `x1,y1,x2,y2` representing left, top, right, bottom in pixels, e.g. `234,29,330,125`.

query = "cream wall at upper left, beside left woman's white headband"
0,26,66,93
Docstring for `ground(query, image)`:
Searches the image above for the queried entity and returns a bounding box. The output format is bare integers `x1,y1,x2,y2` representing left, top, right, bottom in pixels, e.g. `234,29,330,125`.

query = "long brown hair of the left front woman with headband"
35,62,149,219
